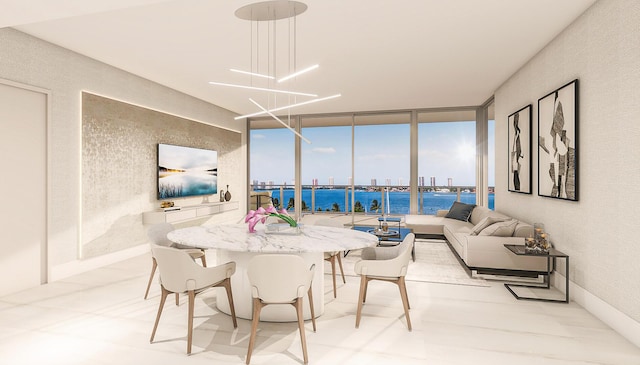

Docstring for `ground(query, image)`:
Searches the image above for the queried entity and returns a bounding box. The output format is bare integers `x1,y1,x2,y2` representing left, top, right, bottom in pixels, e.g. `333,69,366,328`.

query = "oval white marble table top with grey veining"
167,224,378,253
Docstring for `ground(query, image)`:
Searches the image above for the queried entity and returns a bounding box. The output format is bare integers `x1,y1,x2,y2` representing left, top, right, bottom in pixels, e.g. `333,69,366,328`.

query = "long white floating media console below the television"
142,201,239,224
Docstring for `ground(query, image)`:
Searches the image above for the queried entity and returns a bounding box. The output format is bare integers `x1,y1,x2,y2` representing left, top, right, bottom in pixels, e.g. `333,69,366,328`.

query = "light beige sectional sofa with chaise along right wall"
405,206,547,274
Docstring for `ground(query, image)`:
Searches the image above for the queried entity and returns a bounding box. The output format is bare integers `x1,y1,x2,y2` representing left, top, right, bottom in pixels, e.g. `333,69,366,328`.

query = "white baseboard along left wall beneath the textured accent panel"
49,244,149,282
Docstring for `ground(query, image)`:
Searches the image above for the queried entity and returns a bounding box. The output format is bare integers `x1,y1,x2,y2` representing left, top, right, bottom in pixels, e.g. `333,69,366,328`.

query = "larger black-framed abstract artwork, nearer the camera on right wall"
538,79,578,201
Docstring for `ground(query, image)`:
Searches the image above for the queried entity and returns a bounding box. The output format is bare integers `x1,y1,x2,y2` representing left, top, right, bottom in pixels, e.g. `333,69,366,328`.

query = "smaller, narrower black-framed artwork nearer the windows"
508,104,531,194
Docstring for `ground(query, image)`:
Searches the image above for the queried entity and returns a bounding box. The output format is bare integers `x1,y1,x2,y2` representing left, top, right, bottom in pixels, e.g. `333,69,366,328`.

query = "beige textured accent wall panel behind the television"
82,92,244,258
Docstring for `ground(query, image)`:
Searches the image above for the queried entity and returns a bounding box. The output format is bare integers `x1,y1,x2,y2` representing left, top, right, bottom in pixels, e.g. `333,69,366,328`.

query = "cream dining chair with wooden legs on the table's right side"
354,233,415,331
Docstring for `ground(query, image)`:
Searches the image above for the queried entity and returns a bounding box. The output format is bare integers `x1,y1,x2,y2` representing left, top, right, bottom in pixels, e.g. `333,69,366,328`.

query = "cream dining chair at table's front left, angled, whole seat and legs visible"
149,245,238,354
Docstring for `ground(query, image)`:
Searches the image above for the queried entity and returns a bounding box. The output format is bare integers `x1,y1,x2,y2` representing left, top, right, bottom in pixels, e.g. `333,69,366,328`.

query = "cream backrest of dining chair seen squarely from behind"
247,254,314,303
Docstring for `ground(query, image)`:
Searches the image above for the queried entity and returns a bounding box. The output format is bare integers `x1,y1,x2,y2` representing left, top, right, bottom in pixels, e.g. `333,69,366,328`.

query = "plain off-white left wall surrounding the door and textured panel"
0,28,247,279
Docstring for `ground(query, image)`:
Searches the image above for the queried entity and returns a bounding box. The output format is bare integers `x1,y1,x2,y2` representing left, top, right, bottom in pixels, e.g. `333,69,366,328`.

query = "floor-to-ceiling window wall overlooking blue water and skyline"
249,104,495,215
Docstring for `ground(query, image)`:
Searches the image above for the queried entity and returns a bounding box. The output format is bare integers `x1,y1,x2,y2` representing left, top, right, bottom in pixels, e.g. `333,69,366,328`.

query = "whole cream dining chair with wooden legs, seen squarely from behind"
246,254,316,365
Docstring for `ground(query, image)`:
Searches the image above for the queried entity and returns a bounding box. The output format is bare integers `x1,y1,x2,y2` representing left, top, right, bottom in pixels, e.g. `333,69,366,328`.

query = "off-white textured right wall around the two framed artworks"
495,0,640,325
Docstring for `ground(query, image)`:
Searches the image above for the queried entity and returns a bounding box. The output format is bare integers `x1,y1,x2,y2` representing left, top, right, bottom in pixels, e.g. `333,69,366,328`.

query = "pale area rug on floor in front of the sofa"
336,238,490,287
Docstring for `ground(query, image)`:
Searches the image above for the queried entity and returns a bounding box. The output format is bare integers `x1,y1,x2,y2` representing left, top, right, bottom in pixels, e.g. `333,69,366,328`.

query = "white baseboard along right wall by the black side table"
552,272,640,347
